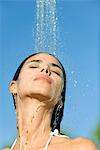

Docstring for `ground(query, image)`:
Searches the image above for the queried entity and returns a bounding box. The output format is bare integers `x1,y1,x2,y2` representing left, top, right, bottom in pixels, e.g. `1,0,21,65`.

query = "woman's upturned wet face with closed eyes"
13,53,63,104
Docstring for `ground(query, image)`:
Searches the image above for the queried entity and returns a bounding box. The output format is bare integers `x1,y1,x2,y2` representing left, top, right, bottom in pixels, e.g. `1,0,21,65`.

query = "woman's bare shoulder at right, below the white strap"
51,137,98,150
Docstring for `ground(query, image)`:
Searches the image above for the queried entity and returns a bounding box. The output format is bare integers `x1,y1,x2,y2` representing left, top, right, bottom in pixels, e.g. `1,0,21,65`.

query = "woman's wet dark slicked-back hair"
12,52,66,132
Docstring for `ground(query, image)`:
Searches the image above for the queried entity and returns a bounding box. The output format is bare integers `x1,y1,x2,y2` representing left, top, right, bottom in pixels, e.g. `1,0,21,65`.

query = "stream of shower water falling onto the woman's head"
35,0,58,55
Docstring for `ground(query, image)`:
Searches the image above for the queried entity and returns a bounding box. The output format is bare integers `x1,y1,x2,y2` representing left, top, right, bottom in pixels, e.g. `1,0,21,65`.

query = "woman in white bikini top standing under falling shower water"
5,53,97,150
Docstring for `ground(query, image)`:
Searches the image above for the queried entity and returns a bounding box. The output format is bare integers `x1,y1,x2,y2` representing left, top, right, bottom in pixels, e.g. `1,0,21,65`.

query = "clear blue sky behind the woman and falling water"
0,0,100,148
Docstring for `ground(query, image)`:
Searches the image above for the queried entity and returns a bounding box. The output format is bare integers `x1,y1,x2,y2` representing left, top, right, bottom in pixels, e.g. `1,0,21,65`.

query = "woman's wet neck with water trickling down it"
16,97,52,150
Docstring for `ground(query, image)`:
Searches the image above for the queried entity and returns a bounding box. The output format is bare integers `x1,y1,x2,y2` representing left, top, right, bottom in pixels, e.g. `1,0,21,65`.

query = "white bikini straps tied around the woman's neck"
10,129,69,150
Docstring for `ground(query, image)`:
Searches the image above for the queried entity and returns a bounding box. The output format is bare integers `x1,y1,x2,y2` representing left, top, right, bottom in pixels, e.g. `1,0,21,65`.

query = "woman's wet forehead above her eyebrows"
26,54,61,66
